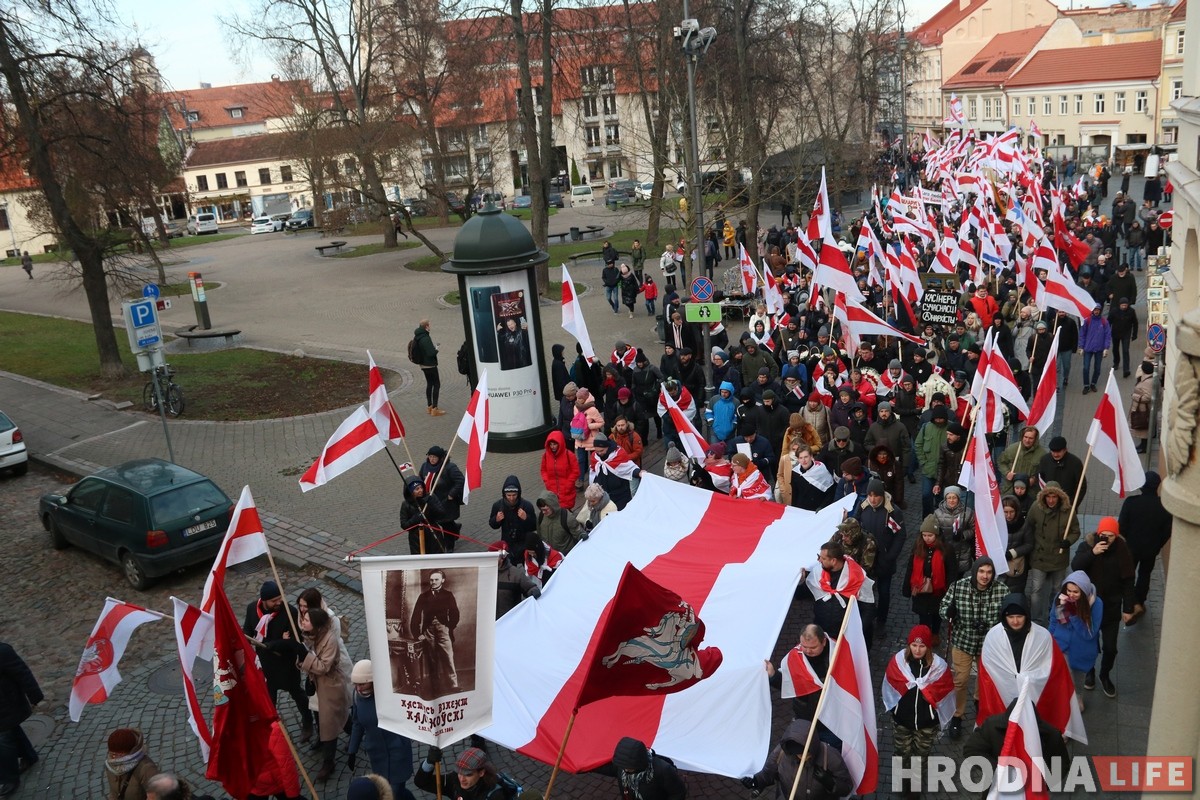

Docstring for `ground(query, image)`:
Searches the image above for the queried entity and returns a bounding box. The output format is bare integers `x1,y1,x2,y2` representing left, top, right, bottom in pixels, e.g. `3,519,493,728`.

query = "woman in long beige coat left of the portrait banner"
300,607,353,781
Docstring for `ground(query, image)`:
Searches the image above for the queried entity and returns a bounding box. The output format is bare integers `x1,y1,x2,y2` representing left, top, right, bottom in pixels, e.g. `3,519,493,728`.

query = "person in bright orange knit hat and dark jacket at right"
1070,517,1138,697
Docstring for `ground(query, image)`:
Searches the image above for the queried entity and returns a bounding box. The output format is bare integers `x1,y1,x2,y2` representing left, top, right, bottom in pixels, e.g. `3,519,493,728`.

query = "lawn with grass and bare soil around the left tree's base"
0,313,396,420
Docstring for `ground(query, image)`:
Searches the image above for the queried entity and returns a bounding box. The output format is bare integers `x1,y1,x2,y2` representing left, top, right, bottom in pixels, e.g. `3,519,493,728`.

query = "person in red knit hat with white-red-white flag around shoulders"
881,625,954,799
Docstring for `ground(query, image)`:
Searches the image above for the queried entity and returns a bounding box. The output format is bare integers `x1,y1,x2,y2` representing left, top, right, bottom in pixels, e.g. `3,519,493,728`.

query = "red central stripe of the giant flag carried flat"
517,494,785,772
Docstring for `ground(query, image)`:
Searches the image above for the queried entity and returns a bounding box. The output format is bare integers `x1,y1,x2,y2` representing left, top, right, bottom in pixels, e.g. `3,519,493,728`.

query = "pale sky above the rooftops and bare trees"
113,0,974,89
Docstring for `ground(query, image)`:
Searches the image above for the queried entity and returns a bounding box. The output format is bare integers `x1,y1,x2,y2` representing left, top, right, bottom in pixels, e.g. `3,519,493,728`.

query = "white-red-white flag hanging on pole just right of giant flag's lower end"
814,597,880,794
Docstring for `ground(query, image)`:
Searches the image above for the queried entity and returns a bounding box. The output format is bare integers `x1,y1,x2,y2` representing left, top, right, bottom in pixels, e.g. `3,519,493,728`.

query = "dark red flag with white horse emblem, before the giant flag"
576,564,721,706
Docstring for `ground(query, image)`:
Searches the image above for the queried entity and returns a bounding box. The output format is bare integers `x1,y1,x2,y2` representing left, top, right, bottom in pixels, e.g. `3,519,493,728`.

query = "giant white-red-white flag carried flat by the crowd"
482,474,850,776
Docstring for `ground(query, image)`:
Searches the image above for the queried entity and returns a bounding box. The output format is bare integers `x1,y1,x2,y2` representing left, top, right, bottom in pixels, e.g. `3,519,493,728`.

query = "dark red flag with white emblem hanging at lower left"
204,585,276,798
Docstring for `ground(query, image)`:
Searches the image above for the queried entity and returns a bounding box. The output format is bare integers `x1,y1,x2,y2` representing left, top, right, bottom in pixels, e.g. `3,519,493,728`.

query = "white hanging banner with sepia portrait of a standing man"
359,552,497,747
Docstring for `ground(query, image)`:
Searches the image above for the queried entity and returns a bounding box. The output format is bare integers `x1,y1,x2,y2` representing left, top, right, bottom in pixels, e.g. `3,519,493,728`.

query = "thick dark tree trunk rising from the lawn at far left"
0,17,125,378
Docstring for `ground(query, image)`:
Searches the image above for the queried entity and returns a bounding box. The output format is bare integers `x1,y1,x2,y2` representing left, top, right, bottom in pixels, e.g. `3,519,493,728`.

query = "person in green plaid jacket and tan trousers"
941,557,1008,739
